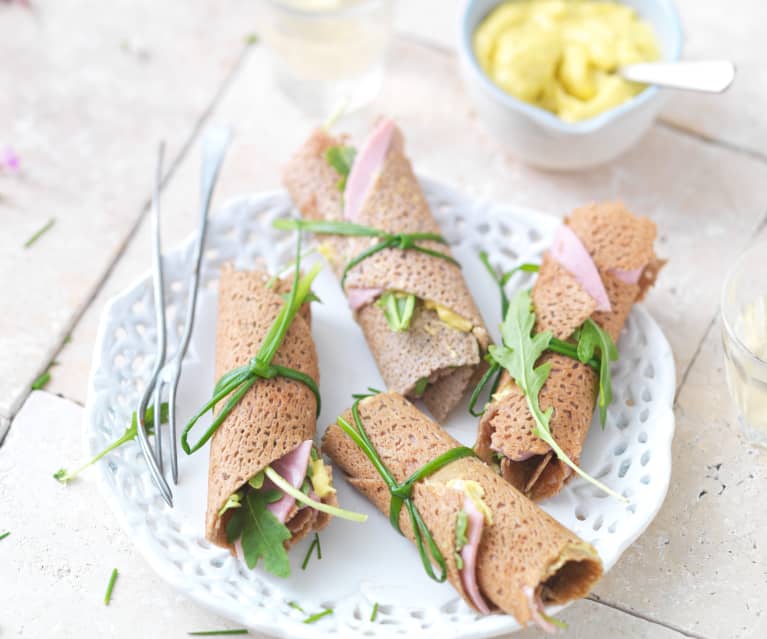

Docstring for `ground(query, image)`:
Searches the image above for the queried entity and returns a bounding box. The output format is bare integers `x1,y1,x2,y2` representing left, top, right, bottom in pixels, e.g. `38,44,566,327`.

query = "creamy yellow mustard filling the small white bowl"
474,0,660,122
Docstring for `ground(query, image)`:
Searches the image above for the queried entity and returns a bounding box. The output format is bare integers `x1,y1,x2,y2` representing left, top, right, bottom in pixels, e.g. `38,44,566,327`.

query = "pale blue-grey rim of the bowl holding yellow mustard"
460,0,684,134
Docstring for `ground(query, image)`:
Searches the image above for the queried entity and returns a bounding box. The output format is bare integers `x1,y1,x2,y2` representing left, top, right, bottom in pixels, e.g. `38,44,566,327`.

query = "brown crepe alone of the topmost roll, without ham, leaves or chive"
283,122,488,420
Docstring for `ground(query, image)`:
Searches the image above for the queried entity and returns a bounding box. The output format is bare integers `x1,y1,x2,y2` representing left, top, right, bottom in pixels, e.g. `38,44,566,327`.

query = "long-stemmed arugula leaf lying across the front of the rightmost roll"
489,289,628,502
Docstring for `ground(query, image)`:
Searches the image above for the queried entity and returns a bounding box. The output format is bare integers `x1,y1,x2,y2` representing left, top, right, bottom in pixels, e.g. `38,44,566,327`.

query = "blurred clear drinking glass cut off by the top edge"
259,0,394,117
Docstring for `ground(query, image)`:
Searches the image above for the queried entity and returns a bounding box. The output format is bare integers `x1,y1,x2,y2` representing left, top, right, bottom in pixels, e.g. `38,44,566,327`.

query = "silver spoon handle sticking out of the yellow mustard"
618,60,735,93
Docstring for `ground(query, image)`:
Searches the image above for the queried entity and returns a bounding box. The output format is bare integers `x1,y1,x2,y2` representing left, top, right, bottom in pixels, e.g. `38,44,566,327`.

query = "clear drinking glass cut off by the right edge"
722,242,767,446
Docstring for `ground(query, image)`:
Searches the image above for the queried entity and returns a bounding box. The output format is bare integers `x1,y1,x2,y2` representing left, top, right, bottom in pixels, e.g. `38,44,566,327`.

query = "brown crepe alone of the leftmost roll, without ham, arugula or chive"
205,266,336,548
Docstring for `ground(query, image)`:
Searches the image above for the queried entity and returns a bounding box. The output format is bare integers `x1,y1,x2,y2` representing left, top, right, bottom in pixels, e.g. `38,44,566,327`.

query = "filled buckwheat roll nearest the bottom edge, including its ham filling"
322,393,602,629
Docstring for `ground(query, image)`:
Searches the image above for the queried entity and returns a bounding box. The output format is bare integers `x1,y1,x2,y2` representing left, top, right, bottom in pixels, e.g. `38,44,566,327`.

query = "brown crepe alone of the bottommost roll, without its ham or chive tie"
322,393,602,624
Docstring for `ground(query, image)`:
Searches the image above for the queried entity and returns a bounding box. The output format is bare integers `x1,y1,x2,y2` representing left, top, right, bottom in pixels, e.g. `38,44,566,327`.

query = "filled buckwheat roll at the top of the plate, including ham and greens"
283,119,488,420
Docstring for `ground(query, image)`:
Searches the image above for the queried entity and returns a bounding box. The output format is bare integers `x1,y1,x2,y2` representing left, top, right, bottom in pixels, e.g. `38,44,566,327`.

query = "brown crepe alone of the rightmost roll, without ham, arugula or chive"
476,202,663,500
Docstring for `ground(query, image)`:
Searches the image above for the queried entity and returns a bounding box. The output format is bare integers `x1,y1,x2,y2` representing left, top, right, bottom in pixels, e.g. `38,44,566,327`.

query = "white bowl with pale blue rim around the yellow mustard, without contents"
458,0,682,171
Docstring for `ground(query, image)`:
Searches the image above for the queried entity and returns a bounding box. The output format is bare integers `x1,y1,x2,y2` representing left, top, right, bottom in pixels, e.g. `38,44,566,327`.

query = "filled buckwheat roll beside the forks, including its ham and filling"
205,267,337,574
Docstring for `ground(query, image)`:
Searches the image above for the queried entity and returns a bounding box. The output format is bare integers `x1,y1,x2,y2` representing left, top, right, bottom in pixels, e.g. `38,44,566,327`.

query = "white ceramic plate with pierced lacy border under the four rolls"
85,180,675,639
